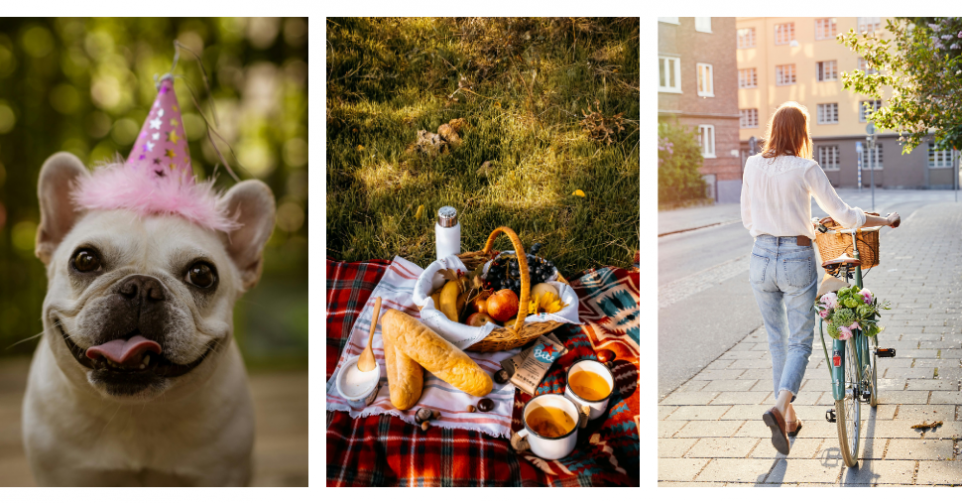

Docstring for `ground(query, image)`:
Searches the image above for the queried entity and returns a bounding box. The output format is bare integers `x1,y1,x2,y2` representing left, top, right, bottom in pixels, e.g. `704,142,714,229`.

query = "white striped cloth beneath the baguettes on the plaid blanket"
327,257,520,438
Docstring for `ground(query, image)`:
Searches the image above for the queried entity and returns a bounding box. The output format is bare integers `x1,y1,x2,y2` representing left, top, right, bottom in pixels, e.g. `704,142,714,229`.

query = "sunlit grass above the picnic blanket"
326,18,639,274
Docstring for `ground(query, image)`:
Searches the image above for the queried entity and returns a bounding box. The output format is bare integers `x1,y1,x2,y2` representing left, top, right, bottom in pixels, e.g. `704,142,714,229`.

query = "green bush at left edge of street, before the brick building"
658,122,705,204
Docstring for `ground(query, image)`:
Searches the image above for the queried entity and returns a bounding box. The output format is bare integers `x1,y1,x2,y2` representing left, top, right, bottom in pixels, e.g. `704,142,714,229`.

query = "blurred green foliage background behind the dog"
0,18,308,367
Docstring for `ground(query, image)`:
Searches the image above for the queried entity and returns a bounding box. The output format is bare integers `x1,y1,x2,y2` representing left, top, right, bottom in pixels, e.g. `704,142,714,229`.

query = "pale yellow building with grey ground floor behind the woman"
736,17,956,189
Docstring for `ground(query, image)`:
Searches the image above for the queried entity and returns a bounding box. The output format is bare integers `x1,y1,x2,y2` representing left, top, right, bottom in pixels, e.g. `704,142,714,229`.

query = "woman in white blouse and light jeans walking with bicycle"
741,101,899,455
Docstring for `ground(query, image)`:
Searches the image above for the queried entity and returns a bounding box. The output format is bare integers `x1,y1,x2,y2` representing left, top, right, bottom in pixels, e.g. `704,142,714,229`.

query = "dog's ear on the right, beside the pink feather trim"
220,180,275,290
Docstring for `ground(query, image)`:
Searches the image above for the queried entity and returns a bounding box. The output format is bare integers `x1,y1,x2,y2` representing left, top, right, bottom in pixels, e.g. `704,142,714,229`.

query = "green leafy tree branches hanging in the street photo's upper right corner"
838,18,962,153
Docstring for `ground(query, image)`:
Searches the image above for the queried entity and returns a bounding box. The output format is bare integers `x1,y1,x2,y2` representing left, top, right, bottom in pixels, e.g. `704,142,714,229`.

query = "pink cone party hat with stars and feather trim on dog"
72,74,239,232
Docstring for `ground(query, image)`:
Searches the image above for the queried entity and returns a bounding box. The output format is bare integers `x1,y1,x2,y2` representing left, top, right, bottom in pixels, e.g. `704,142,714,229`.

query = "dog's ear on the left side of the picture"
34,152,90,264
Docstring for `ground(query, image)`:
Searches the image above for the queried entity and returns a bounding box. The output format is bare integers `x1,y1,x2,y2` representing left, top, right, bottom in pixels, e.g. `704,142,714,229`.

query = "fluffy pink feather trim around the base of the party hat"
71,163,241,232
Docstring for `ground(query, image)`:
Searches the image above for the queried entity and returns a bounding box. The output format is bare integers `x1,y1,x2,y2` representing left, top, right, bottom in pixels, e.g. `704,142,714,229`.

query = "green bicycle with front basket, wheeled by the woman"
812,218,898,468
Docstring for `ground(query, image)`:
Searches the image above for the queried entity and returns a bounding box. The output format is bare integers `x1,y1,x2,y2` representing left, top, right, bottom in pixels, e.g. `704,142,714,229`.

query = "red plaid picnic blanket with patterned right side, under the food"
326,259,640,486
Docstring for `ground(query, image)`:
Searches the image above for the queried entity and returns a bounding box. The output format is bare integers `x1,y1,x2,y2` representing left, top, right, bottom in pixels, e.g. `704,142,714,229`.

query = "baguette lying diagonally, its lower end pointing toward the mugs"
381,309,494,400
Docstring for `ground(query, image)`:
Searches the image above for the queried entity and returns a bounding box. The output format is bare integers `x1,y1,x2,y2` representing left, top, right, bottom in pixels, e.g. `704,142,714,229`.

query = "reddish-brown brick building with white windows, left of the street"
658,17,742,203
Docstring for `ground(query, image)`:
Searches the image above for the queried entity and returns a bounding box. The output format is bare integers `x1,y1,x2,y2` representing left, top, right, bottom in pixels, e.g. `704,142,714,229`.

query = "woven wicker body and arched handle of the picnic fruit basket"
458,227,568,352
